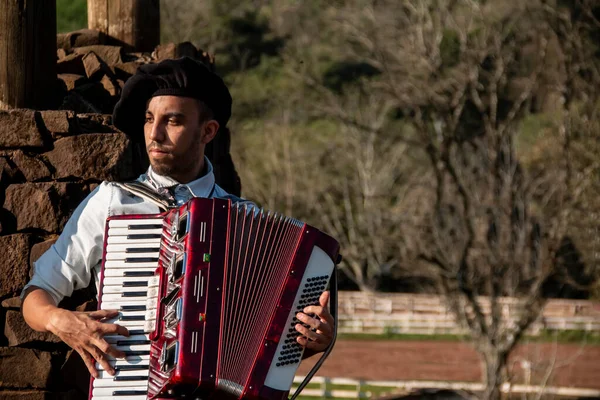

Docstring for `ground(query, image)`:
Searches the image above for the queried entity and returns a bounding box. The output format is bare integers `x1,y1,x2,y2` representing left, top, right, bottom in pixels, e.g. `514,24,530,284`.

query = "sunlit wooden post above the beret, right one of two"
88,0,160,51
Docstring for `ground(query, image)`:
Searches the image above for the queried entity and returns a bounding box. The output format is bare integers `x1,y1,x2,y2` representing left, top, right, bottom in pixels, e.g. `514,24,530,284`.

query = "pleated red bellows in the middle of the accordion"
218,206,304,395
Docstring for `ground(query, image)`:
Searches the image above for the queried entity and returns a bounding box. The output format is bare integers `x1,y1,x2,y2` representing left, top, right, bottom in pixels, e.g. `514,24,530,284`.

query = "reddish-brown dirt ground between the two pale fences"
297,340,600,389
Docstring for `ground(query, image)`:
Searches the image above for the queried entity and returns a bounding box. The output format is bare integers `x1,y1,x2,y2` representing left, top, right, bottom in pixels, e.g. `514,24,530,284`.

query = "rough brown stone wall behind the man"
0,30,240,399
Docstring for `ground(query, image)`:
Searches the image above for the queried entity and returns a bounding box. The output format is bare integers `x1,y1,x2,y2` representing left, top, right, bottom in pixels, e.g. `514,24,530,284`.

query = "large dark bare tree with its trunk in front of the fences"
284,0,598,399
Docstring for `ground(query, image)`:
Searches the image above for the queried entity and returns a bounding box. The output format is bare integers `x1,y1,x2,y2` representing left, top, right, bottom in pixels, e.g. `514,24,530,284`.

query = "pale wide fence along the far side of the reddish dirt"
339,292,600,335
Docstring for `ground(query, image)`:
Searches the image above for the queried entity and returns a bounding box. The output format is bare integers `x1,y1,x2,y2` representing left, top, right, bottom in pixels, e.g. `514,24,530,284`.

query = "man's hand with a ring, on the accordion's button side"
296,291,334,353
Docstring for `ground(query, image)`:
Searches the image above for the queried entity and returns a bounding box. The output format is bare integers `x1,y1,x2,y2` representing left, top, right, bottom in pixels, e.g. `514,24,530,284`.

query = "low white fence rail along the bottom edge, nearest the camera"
292,376,600,399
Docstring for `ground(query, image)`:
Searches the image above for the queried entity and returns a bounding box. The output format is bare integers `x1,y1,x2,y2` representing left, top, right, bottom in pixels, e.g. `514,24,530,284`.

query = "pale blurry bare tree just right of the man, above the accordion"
233,85,424,291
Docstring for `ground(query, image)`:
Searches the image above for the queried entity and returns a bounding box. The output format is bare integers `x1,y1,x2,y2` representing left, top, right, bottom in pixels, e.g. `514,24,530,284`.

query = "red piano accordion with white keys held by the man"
90,198,339,400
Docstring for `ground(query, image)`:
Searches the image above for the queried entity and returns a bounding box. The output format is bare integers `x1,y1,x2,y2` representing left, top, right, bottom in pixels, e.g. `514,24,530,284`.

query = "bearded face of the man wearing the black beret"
144,96,218,183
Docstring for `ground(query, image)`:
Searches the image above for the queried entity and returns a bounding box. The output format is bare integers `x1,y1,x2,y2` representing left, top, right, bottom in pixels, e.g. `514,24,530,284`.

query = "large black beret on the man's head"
113,57,231,139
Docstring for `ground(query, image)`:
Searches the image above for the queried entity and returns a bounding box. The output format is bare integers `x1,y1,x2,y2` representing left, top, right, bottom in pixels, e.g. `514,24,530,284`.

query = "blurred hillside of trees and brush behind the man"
57,0,600,298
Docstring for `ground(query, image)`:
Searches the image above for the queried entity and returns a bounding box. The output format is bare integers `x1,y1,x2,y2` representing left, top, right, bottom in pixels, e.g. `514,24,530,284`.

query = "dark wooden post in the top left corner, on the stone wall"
0,0,56,110
